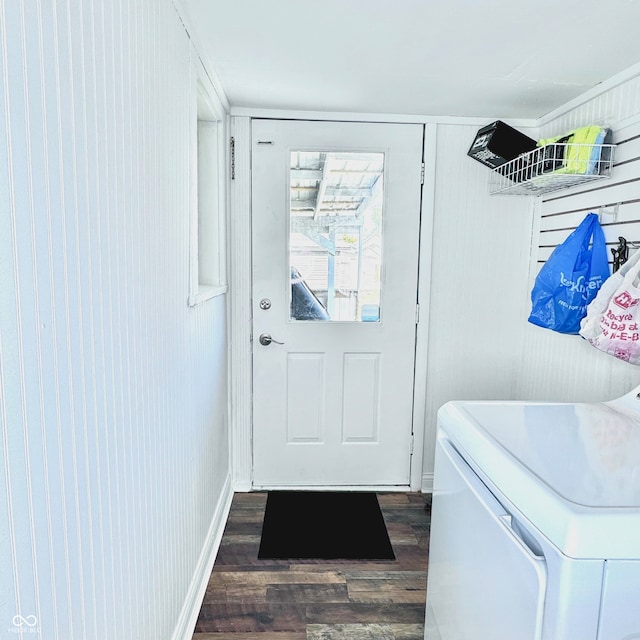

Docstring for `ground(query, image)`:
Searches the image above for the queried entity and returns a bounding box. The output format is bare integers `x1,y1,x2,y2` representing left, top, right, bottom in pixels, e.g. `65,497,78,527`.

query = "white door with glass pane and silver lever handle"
252,120,423,488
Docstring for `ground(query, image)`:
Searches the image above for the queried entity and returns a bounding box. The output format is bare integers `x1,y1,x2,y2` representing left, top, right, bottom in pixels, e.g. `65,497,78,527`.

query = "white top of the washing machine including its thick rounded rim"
436,396,640,559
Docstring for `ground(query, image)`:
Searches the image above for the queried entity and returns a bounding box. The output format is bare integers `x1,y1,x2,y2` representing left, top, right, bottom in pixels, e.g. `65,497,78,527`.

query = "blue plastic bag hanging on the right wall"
529,213,610,334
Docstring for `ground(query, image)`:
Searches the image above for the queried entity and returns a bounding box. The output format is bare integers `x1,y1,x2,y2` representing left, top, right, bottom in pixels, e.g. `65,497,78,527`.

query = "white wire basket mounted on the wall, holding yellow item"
489,143,615,195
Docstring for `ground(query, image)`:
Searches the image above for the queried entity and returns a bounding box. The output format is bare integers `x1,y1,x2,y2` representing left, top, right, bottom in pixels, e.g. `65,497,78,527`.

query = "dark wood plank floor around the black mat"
193,493,429,640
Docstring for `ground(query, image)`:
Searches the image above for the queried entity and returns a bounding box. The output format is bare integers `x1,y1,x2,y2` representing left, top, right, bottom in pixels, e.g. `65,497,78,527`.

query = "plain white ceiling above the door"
178,0,640,118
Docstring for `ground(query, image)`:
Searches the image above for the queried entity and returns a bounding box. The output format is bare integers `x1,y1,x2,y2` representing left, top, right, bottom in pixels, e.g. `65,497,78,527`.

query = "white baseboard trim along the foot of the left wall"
171,475,233,640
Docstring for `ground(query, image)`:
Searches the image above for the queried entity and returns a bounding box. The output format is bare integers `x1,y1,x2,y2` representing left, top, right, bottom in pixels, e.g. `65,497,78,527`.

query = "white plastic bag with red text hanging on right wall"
580,251,640,364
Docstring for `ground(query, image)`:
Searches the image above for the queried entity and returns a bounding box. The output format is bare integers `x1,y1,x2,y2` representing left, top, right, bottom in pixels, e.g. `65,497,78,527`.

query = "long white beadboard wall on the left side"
0,0,231,640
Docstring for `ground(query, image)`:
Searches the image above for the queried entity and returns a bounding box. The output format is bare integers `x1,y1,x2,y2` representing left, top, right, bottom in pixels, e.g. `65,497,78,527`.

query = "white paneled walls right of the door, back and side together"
423,68,640,490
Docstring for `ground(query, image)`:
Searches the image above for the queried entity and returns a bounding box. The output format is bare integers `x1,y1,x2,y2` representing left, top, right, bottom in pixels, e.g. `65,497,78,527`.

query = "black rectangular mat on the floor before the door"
258,491,395,560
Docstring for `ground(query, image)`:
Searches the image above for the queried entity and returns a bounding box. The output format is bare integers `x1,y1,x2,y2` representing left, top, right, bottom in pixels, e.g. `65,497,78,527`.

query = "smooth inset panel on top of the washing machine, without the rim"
464,403,640,507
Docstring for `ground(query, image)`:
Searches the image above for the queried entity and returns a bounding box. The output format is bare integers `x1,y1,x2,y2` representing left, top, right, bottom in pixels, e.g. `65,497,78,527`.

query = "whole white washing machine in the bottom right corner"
425,387,640,640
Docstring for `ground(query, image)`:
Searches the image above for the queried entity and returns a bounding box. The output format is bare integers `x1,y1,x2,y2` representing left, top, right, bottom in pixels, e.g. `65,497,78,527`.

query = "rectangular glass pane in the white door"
289,151,384,322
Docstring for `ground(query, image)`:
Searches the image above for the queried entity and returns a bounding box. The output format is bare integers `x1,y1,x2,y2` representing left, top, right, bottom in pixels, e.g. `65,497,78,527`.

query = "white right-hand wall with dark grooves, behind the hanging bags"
517,77,640,401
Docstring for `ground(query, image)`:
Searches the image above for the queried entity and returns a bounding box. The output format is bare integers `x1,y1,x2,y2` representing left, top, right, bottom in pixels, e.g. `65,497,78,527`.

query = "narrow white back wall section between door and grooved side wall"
423,124,536,489
